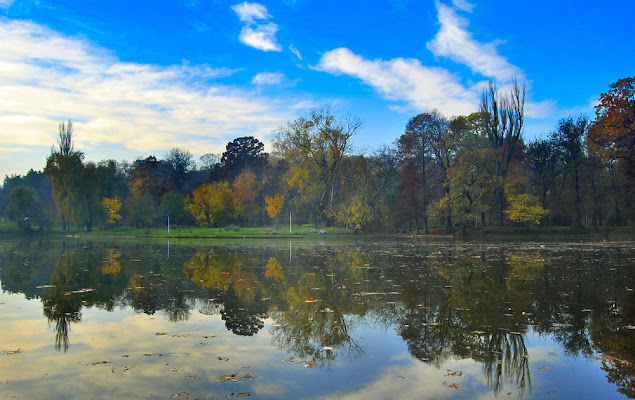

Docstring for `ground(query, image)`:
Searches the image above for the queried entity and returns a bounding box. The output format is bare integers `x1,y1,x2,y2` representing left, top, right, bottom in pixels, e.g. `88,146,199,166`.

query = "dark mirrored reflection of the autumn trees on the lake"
0,240,635,397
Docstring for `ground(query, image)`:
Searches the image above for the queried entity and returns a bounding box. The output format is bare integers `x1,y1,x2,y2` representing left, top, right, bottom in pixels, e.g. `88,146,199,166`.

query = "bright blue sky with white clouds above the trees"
0,0,635,177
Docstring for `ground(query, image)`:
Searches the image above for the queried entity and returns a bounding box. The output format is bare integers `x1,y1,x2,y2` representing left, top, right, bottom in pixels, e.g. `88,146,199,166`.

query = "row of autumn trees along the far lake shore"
0,77,635,233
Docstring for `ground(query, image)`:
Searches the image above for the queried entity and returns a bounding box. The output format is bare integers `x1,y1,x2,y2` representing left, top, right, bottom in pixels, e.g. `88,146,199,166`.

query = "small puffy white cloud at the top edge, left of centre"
231,2,282,51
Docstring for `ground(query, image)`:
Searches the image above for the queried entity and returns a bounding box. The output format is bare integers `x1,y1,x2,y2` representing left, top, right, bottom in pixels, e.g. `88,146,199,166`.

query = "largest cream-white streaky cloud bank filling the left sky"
0,20,298,170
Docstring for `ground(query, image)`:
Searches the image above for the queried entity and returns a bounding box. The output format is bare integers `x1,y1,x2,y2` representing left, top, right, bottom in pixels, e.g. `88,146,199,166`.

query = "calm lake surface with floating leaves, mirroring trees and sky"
0,239,635,400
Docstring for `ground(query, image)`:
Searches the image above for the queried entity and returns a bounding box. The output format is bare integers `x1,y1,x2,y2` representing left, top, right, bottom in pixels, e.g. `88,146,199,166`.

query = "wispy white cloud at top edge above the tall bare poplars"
427,0,523,82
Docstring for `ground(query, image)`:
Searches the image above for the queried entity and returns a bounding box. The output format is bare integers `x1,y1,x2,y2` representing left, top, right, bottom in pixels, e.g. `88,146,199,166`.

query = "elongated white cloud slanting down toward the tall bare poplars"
315,48,479,115
